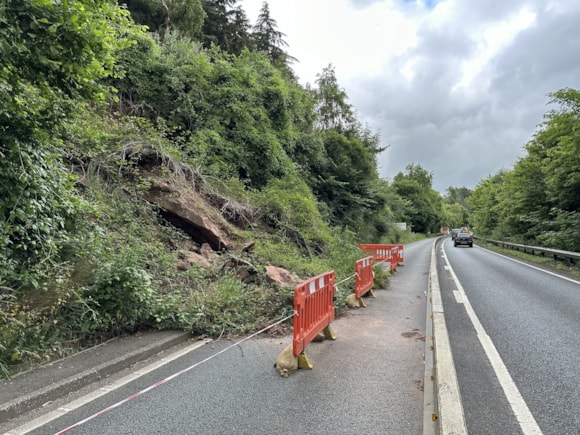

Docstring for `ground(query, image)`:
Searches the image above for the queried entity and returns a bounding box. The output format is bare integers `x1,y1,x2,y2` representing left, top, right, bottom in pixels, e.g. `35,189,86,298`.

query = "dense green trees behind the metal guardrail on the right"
469,89,580,252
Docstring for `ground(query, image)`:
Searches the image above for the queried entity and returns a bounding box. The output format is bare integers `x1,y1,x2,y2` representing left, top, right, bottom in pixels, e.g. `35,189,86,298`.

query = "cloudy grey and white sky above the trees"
238,0,580,193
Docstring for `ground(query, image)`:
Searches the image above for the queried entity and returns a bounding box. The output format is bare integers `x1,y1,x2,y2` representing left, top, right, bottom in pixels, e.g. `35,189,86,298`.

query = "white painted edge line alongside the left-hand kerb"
4,339,212,435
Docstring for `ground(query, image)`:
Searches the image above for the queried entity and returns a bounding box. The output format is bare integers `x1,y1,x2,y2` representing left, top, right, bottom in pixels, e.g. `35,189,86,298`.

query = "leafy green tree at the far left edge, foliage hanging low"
0,0,138,285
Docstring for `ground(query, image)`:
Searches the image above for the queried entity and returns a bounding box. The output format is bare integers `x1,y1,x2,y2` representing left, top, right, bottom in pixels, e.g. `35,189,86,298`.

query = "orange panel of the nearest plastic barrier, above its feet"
292,271,336,356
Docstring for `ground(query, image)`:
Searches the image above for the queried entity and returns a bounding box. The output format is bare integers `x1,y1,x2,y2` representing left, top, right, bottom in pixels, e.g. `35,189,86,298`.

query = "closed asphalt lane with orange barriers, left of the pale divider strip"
2,240,433,434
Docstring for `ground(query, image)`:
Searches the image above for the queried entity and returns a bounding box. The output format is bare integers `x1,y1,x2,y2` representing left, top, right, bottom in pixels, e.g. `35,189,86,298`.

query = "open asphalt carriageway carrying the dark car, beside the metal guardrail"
437,240,580,435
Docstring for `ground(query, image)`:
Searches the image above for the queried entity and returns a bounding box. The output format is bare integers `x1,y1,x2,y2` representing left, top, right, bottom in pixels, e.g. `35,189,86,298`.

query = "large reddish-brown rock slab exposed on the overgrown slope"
144,178,229,252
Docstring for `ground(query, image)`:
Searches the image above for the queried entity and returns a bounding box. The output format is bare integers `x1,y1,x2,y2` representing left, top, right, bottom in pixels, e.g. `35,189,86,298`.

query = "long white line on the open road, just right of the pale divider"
441,244,542,435
